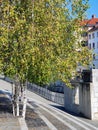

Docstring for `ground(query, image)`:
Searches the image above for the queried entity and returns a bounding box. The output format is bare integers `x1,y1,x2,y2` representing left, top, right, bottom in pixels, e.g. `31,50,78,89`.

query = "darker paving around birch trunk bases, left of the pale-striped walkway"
0,90,49,130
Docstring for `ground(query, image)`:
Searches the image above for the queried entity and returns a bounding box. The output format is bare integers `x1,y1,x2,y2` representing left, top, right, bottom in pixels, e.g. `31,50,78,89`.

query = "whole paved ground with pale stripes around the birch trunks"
0,80,98,130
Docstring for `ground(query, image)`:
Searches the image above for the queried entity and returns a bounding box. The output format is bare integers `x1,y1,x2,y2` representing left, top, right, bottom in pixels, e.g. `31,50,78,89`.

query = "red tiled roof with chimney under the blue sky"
81,15,98,26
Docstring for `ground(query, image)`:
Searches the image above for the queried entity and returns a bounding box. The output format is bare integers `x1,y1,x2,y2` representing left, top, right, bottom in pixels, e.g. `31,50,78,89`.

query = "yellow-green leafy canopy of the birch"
0,0,90,85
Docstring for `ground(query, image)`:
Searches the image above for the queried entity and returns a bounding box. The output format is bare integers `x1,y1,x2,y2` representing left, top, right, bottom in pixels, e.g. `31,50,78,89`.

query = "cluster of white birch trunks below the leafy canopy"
12,77,27,118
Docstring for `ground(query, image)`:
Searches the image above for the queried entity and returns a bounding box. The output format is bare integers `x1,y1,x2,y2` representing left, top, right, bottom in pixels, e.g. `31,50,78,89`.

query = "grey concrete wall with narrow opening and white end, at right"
64,69,98,120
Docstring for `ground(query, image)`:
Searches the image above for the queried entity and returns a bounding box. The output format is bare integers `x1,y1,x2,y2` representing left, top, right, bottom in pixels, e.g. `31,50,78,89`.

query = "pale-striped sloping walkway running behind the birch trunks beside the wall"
0,80,98,130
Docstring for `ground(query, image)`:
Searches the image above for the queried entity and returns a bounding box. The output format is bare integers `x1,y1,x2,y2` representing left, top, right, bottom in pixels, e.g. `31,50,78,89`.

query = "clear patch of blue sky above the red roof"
87,0,98,19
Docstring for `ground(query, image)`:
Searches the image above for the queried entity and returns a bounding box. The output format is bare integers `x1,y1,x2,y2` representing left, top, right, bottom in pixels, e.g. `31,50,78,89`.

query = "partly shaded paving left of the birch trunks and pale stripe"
0,90,21,130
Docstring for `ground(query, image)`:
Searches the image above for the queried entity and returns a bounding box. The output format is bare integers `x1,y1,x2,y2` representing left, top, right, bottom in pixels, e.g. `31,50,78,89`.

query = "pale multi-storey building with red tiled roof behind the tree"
82,15,98,69
